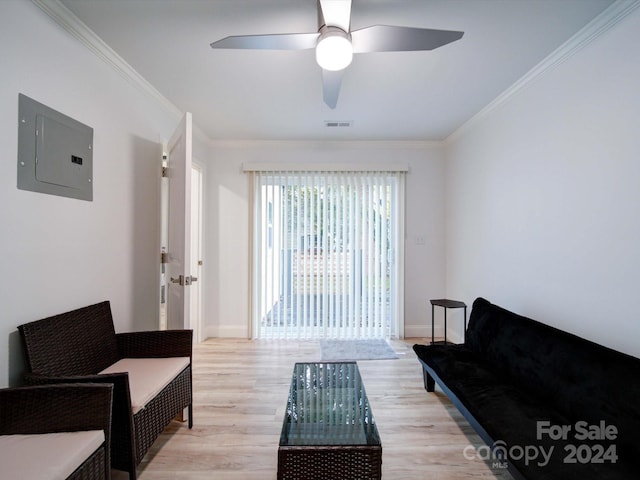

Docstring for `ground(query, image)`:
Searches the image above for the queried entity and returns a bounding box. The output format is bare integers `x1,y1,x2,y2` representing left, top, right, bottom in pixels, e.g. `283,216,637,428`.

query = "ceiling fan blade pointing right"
351,25,464,53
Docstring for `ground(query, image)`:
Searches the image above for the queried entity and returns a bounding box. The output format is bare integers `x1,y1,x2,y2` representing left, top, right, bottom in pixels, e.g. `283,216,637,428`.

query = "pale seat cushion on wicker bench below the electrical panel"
100,357,189,415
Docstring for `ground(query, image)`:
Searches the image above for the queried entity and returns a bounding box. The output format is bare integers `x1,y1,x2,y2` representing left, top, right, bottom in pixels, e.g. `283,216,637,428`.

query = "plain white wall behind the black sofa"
446,3,640,356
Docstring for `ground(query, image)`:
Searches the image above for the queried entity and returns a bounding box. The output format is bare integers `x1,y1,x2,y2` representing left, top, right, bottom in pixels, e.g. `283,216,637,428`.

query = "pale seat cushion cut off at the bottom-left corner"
0,430,104,480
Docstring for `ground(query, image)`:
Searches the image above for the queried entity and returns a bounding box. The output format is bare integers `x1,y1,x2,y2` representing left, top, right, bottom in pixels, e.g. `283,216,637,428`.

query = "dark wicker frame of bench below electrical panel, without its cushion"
18,301,193,480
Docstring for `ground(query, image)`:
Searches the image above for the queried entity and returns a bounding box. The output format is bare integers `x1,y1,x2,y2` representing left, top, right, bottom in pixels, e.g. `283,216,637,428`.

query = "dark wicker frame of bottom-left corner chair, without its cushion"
0,384,113,480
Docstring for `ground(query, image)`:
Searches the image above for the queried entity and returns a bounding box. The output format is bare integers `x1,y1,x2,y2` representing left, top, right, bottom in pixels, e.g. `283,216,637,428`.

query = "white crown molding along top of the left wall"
31,0,209,141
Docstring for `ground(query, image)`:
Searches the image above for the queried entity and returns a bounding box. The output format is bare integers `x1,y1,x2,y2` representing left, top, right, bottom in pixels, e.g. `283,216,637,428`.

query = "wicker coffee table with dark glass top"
278,362,382,480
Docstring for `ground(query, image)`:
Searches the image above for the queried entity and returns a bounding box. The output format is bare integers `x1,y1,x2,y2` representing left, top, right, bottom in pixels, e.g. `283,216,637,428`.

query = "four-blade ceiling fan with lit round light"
211,0,464,108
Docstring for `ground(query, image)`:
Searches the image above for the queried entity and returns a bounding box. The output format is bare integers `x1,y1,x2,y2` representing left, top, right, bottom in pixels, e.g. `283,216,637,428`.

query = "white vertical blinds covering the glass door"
252,167,404,338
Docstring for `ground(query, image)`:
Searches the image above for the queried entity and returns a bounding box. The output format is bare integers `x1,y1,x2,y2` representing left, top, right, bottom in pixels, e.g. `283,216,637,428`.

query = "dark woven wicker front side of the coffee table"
278,445,382,480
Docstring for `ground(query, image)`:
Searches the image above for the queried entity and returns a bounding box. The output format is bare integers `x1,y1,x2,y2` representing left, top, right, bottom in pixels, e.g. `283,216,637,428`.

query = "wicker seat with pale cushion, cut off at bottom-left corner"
0,384,113,480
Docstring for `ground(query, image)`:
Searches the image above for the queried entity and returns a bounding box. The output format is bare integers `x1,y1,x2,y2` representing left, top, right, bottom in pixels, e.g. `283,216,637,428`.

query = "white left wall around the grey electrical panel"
0,0,185,387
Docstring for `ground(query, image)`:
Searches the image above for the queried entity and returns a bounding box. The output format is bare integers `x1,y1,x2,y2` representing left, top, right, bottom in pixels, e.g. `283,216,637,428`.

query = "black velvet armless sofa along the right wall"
413,298,640,480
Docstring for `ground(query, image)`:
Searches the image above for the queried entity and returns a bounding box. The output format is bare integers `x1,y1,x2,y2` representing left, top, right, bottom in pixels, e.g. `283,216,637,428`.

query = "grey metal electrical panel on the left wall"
18,94,93,201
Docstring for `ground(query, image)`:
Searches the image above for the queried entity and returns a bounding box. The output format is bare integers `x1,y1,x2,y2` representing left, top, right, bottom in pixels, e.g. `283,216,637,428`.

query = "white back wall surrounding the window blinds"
203,142,445,337
